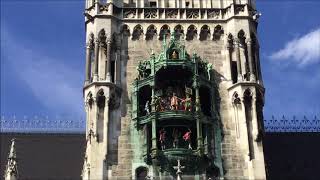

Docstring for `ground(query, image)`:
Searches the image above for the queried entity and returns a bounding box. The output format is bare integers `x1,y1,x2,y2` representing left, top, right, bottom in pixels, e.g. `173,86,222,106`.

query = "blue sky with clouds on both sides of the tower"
1,0,320,122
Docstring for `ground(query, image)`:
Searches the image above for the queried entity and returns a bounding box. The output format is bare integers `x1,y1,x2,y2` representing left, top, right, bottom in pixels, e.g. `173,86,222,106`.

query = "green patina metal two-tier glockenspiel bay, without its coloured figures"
131,33,223,175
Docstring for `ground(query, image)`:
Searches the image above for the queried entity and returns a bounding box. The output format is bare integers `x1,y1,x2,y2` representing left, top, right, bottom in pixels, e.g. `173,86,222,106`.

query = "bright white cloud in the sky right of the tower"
270,28,320,66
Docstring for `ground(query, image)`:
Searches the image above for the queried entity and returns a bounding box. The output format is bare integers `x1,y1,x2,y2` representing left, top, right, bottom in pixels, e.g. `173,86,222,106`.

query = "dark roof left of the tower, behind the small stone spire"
0,133,85,180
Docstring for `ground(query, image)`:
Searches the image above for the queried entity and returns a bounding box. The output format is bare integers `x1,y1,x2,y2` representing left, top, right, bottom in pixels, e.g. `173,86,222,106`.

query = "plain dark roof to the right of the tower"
264,133,320,180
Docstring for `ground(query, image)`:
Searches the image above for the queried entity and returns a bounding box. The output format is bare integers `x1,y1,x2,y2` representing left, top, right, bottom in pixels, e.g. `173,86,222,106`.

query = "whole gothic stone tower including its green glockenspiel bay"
82,0,266,179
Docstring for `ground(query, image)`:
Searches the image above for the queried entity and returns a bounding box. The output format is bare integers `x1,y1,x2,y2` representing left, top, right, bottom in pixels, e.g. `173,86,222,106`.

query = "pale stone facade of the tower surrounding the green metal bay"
82,0,266,179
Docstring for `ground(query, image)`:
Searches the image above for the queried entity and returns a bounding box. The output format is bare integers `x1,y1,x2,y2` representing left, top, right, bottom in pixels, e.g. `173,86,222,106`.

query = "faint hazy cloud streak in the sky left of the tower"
1,28,84,115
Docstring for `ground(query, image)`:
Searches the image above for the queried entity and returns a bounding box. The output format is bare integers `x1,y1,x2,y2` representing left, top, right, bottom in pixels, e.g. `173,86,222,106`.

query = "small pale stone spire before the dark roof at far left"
5,139,18,180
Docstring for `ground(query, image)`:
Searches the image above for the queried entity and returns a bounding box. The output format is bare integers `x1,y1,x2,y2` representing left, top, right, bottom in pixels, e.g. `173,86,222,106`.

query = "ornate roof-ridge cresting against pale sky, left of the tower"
0,116,86,133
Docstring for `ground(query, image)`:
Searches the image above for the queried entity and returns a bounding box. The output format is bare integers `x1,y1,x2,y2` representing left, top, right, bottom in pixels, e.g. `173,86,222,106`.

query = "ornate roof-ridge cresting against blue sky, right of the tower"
264,116,320,132
